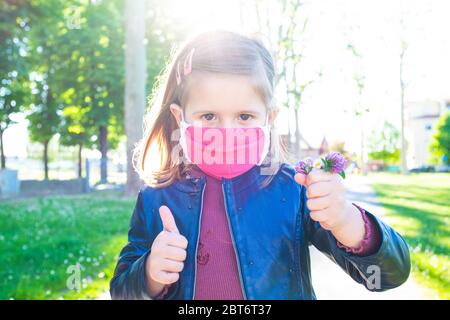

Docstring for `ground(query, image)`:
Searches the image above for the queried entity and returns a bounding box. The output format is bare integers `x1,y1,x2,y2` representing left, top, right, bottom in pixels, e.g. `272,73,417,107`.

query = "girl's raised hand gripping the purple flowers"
294,168,365,247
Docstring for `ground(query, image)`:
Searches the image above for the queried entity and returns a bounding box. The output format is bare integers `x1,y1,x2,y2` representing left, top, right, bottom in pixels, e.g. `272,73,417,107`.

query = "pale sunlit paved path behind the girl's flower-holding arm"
310,176,432,300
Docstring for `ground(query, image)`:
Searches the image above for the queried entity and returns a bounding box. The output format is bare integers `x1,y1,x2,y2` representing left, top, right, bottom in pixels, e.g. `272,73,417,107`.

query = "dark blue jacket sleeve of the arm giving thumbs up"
110,191,177,300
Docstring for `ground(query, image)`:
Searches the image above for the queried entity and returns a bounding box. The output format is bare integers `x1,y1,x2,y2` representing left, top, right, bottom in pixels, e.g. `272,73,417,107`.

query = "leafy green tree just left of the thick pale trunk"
26,0,124,183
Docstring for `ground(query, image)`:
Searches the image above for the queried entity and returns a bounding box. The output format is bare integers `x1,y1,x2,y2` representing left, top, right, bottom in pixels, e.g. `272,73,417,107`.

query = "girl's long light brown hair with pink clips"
133,31,285,187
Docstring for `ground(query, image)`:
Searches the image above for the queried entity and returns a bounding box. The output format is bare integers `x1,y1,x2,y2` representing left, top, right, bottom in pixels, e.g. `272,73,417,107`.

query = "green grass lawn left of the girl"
0,193,136,299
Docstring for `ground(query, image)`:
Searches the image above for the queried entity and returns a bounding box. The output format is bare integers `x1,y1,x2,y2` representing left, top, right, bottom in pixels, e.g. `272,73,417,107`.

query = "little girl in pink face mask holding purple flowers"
110,31,410,299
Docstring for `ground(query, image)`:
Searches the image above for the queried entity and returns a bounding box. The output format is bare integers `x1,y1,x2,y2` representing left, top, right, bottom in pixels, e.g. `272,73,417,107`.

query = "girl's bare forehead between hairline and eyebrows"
185,74,265,113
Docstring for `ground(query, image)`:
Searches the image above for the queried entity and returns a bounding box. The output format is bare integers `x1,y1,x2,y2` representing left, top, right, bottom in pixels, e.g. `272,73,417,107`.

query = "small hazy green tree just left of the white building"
368,121,400,163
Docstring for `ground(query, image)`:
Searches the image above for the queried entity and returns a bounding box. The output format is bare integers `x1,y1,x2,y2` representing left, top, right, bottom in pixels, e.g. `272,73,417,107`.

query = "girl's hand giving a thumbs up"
146,206,188,297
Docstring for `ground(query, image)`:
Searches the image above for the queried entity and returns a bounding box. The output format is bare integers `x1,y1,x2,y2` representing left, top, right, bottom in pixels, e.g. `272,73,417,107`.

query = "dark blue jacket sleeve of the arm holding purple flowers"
301,186,411,291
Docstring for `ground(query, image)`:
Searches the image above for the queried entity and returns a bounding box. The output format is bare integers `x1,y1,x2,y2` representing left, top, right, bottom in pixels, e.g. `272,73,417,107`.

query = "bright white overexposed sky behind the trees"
4,0,450,157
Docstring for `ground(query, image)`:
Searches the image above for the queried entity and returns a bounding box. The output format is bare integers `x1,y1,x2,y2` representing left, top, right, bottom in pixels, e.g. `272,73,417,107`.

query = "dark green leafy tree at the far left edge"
0,0,67,179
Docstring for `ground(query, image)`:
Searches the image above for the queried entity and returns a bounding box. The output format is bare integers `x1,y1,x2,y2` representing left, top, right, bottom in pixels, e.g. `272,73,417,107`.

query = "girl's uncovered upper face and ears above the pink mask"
170,74,276,128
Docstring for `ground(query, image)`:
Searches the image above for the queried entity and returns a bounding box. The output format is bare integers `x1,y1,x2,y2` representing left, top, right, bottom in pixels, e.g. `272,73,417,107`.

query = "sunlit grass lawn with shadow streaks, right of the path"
369,173,450,299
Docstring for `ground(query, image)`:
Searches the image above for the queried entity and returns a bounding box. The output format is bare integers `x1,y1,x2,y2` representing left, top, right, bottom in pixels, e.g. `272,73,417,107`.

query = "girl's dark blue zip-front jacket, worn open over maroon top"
110,164,410,299
